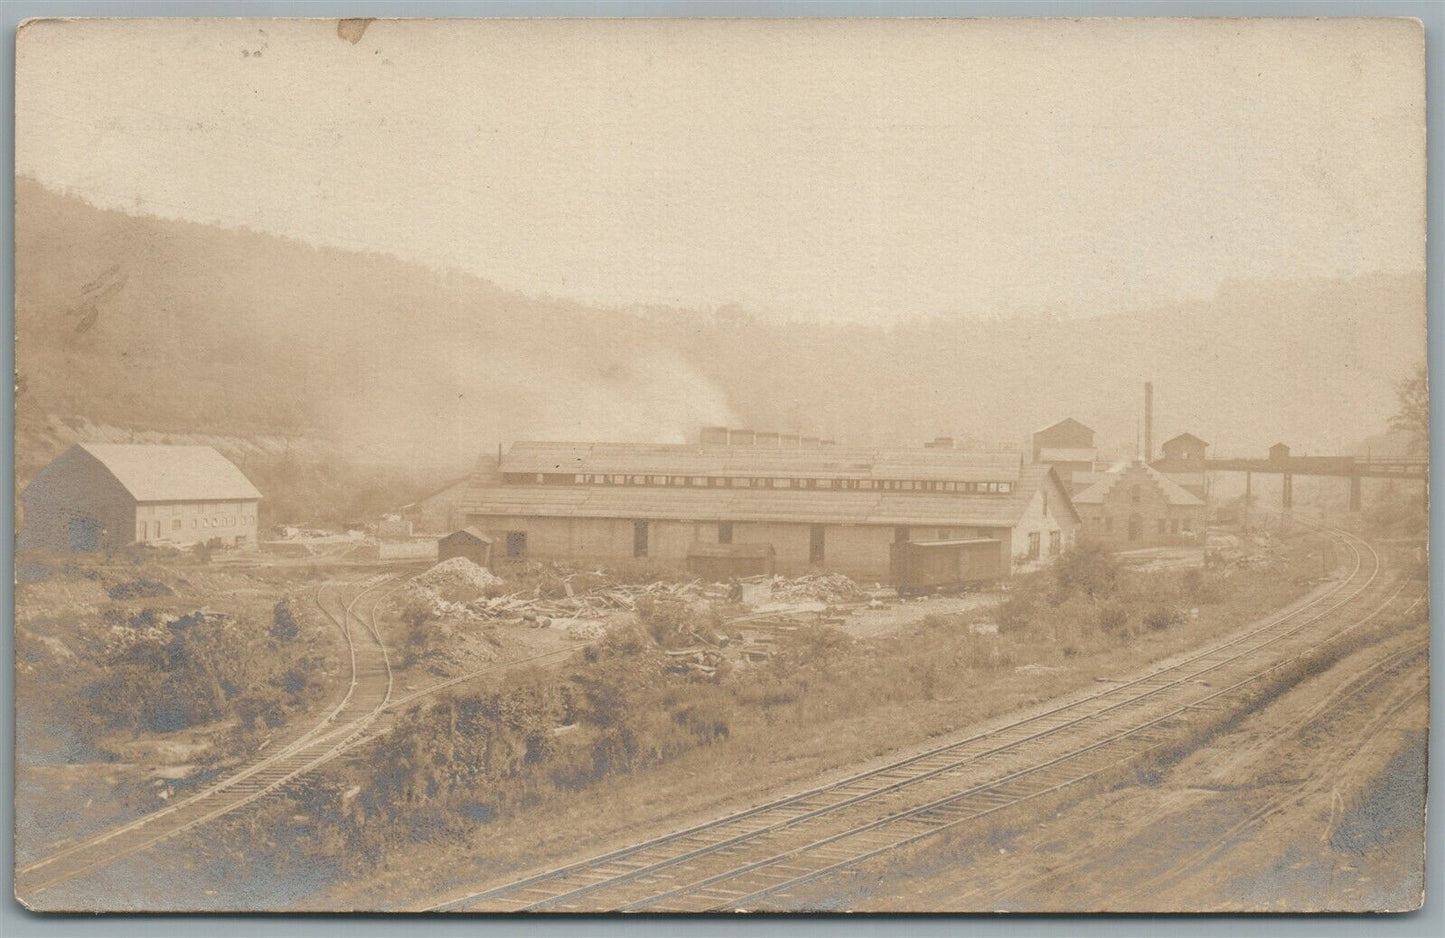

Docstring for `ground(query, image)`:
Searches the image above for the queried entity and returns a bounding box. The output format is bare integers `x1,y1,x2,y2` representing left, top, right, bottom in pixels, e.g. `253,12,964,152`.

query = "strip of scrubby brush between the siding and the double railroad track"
183,539,1319,896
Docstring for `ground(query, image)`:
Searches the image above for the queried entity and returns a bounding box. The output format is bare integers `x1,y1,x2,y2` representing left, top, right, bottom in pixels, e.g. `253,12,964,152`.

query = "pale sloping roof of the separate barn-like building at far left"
77,442,262,502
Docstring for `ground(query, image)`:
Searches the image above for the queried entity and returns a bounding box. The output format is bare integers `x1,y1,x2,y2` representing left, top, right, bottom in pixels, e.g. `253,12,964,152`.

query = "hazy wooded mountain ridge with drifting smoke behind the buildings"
16,179,1425,464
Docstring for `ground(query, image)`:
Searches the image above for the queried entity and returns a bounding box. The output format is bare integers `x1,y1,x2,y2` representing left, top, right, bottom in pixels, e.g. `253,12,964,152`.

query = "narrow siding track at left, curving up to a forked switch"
14,574,396,899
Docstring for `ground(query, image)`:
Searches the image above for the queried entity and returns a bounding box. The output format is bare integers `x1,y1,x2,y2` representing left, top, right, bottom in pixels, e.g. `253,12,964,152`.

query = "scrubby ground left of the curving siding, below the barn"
14,552,344,851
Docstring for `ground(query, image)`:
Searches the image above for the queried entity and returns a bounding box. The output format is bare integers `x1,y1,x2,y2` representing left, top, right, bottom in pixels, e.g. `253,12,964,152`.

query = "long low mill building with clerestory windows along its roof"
461,429,1079,580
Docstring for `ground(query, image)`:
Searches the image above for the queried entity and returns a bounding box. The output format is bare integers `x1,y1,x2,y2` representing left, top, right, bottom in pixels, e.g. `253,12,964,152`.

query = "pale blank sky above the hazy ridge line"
16,20,1425,318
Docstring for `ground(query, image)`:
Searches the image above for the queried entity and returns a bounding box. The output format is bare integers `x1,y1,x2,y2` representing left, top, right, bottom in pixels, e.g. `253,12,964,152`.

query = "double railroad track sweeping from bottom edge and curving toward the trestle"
429,530,1403,912
